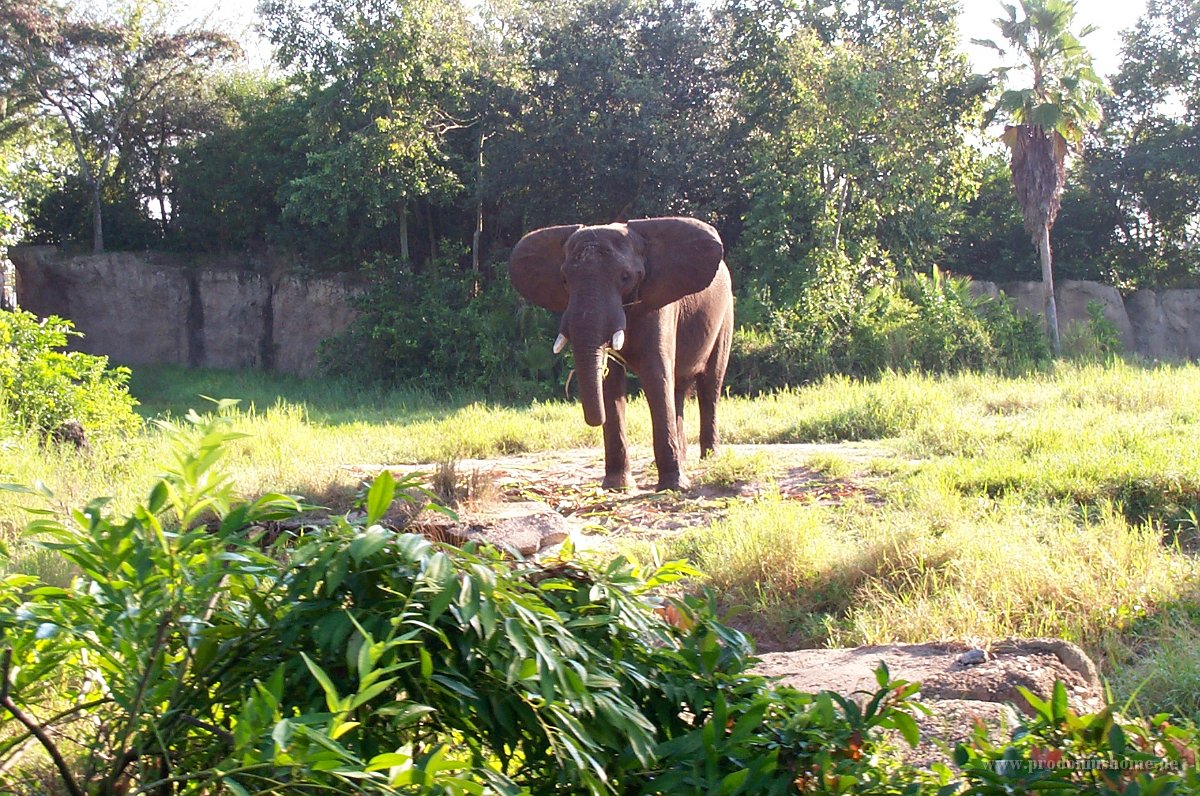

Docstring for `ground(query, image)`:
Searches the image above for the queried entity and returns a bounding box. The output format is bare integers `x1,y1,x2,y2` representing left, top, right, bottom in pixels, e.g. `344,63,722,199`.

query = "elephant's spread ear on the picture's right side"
628,219,725,309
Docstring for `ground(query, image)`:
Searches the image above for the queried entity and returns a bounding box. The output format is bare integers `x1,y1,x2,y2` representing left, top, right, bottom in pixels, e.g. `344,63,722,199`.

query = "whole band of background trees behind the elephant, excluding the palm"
0,0,1200,386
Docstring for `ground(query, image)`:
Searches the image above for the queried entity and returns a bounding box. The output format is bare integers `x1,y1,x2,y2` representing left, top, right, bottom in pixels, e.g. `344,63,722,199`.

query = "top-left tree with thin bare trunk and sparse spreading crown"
0,0,238,252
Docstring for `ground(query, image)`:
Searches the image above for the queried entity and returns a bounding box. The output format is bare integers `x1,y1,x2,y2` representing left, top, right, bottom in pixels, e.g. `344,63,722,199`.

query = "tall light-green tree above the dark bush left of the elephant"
259,0,473,267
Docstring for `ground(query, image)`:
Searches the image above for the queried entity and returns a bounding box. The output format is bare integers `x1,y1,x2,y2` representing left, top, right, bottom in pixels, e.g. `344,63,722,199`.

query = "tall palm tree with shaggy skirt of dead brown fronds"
974,0,1108,354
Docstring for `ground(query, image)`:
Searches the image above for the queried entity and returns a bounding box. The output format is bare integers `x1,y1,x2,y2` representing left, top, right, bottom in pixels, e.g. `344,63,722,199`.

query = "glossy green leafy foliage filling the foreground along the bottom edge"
0,414,1200,796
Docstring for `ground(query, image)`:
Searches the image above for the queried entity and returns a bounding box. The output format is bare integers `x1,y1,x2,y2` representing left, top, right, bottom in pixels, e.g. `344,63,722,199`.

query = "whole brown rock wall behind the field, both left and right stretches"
9,246,1200,376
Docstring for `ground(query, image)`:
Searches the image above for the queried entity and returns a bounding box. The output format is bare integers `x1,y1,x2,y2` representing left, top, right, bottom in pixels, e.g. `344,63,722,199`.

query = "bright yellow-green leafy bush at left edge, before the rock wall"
0,311,140,438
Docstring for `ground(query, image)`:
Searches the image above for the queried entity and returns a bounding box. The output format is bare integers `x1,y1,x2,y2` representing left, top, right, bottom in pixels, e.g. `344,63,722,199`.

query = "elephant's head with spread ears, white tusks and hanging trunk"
509,219,725,426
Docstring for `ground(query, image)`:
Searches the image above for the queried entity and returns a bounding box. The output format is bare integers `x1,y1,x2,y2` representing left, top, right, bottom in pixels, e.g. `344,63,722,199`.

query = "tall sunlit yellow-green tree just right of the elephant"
722,0,980,309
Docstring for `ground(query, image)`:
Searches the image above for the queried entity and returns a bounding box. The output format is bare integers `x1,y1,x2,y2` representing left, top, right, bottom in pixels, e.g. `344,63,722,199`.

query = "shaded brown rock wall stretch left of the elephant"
10,246,362,376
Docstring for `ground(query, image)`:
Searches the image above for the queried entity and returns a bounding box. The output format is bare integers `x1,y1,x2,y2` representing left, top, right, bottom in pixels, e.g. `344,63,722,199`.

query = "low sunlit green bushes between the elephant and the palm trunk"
728,267,1049,393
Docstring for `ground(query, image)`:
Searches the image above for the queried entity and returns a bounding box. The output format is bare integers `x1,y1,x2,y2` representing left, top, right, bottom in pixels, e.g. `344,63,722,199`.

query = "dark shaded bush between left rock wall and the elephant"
323,257,565,399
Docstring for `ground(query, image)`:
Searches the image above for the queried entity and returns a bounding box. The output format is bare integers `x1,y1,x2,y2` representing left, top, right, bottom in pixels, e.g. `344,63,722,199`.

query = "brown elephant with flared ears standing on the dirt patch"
509,217,733,491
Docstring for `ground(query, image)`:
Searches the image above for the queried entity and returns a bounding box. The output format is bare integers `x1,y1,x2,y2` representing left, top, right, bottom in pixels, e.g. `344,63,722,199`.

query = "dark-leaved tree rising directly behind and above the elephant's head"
488,0,733,235
